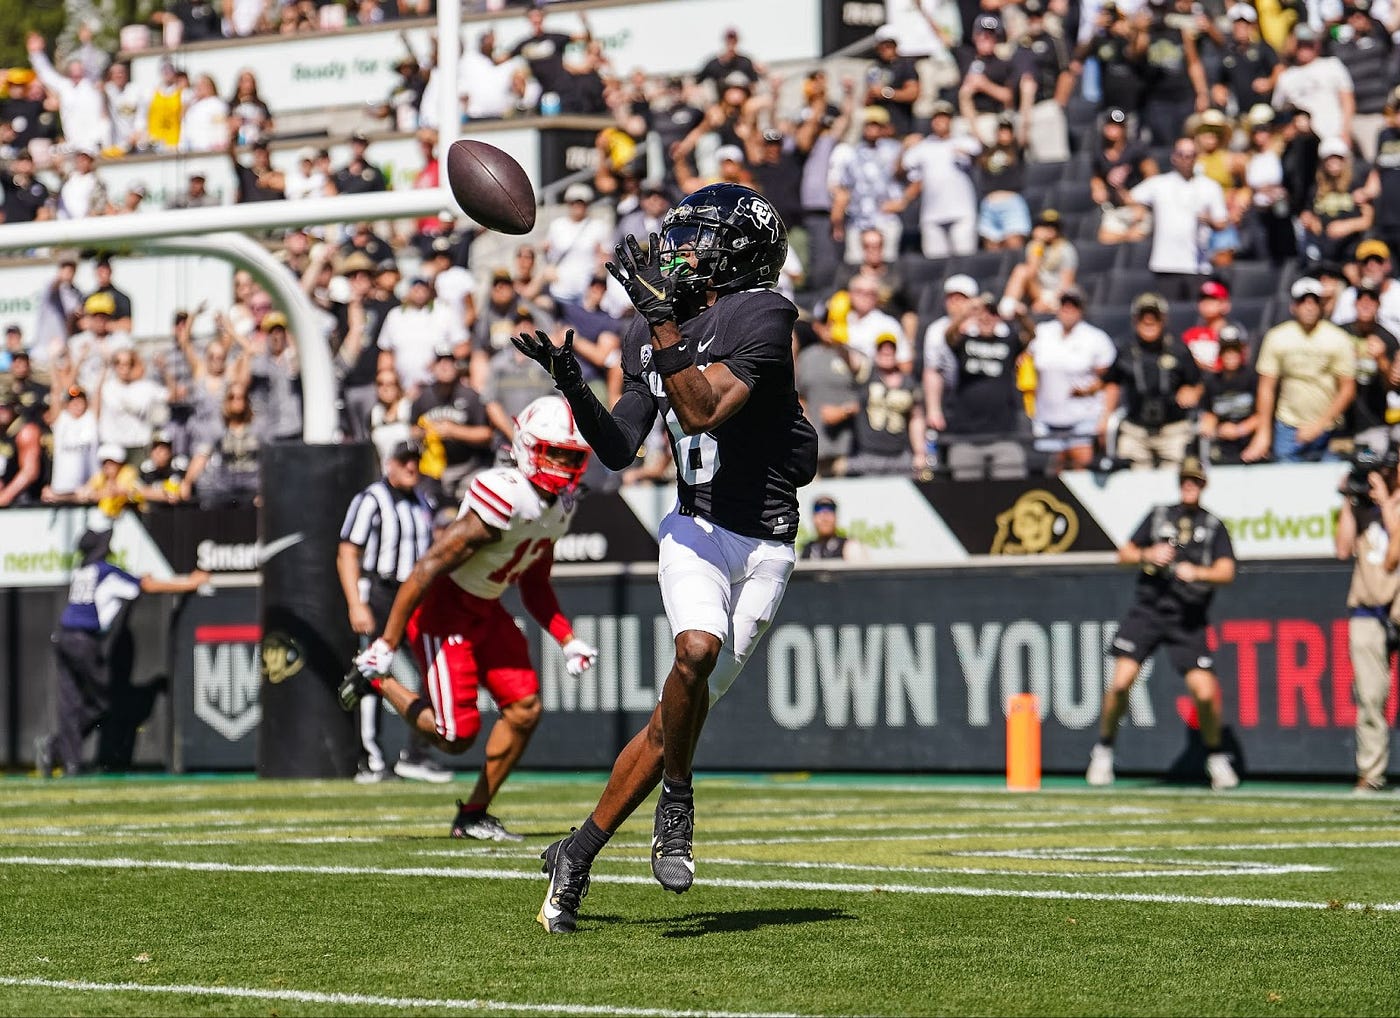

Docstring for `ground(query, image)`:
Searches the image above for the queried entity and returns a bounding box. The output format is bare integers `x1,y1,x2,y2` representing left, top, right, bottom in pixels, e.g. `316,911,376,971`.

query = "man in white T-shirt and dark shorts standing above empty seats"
1128,137,1229,301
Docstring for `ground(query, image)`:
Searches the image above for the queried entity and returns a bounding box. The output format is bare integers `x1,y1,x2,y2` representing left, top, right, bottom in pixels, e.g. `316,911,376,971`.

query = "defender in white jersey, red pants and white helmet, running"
340,396,598,842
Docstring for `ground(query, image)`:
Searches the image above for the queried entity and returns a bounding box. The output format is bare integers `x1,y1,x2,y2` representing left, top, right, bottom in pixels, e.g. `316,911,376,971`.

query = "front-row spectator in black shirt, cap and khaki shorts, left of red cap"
1100,293,1201,466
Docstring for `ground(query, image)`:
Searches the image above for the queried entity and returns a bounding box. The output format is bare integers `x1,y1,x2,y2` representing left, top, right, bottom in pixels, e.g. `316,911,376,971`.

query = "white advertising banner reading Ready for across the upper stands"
132,0,820,113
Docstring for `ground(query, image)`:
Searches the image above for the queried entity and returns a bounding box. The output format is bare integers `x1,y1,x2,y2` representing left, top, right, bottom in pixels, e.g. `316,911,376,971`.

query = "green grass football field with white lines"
0,774,1400,1017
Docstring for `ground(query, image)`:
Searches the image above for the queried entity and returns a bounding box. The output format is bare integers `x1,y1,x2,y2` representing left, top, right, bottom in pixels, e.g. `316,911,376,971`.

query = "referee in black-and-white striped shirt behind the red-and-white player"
336,441,452,784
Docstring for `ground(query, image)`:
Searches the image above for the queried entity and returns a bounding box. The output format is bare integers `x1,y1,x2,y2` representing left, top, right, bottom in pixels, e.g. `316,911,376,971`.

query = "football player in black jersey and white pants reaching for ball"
515,183,816,933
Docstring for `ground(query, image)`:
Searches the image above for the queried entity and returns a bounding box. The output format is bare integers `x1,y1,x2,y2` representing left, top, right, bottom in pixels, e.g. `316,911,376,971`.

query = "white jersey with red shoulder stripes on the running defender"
451,466,577,601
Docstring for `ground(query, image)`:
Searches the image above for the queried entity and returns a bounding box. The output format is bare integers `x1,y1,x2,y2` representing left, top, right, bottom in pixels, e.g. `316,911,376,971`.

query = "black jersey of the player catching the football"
616,290,816,543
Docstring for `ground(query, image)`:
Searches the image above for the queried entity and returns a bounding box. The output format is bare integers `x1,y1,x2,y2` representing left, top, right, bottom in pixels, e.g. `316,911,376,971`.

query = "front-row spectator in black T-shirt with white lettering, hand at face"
939,293,1035,480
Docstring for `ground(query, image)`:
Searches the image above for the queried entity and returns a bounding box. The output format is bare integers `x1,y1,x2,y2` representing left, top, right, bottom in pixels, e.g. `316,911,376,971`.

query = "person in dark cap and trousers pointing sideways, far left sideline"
34,531,209,777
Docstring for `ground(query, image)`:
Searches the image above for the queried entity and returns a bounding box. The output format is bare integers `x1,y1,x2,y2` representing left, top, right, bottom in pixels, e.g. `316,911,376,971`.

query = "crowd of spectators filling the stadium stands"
0,0,1400,504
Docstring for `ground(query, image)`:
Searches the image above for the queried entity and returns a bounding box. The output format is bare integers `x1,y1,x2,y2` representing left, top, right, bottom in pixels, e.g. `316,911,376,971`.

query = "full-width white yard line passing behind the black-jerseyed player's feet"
0,856,1383,912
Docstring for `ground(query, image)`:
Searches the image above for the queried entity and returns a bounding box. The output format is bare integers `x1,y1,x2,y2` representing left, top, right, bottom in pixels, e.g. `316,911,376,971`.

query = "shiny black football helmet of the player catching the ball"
661,183,787,294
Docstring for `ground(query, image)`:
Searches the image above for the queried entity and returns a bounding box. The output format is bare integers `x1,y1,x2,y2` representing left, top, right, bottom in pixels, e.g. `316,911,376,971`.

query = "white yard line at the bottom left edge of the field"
0,976,791,1018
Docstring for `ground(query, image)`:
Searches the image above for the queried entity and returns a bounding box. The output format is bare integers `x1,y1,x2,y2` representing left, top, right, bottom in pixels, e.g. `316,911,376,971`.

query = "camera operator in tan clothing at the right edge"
1336,449,1400,794
